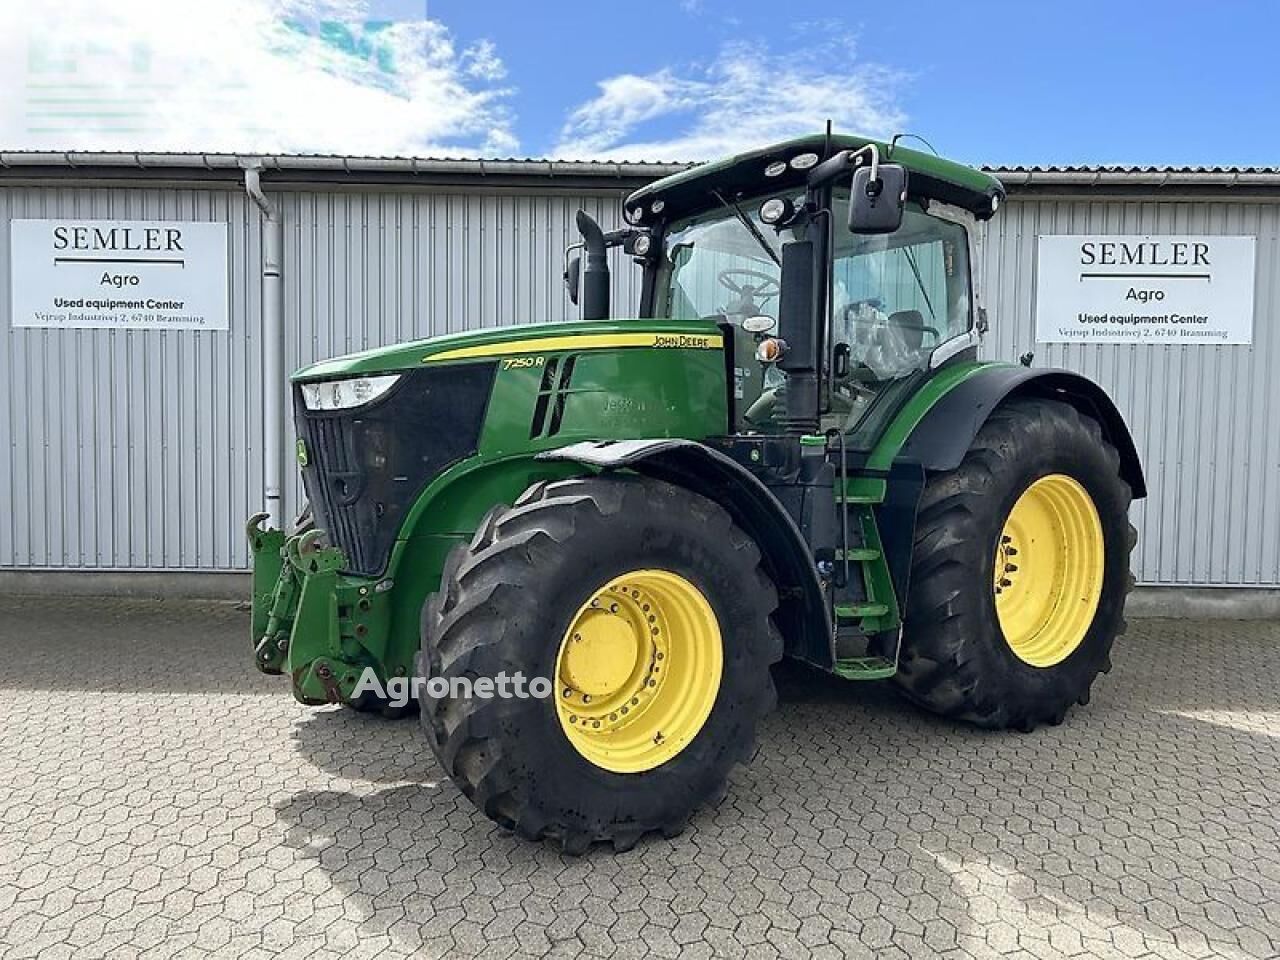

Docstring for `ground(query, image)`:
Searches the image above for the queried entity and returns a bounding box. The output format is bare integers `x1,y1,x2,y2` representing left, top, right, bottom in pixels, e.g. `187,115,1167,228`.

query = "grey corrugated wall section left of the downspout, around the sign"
0,188,262,570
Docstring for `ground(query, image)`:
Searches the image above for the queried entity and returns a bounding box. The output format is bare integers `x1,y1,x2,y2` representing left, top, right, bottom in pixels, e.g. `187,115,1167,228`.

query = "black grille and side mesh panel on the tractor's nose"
293,362,497,576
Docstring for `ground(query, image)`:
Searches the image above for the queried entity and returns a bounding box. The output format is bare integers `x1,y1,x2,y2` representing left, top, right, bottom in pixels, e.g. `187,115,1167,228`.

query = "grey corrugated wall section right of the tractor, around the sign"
983,197,1280,586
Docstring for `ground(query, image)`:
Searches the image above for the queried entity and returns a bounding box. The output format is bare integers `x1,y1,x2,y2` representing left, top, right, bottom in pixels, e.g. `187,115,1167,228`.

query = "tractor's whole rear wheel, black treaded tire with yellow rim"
896,399,1135,731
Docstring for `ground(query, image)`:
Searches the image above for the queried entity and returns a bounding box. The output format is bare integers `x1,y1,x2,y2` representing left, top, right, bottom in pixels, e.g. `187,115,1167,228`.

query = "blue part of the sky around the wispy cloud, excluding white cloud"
430,0,1280,165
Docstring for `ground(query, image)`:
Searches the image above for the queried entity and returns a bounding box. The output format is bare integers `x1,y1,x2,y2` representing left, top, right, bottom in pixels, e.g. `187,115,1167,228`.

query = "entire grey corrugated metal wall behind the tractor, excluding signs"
0,179,1280,585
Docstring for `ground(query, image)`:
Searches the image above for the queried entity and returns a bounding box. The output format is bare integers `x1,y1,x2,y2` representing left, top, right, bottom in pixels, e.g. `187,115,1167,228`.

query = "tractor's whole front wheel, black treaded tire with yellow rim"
417,474,782,852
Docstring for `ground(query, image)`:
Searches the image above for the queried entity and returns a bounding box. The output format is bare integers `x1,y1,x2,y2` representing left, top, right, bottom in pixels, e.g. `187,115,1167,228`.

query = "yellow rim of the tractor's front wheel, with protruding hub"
556,570,724,773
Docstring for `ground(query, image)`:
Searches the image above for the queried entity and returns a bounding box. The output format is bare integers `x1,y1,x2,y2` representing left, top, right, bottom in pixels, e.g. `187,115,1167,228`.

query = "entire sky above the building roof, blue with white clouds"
0,0,1280,165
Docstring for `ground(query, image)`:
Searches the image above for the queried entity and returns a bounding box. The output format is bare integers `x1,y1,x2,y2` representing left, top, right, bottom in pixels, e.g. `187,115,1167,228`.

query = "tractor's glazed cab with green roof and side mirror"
623,137,1004,443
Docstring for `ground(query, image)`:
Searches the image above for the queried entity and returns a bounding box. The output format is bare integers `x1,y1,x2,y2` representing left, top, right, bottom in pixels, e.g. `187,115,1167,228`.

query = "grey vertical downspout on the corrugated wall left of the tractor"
244,160,284,529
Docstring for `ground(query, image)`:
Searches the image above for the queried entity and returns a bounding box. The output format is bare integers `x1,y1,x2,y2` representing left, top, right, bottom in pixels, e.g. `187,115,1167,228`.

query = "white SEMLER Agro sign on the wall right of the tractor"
1036,234,1256,344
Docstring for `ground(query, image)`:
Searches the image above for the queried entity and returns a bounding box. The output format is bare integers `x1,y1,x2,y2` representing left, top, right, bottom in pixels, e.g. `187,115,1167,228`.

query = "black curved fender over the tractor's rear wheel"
895,364,1147,499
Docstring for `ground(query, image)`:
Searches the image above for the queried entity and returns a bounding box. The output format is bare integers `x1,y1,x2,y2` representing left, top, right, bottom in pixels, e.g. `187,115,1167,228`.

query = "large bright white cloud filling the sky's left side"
0,0,518,156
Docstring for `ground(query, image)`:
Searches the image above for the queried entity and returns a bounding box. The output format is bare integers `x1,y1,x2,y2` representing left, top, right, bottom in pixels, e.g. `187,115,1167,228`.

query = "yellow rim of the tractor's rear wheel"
995,474,1106,667
